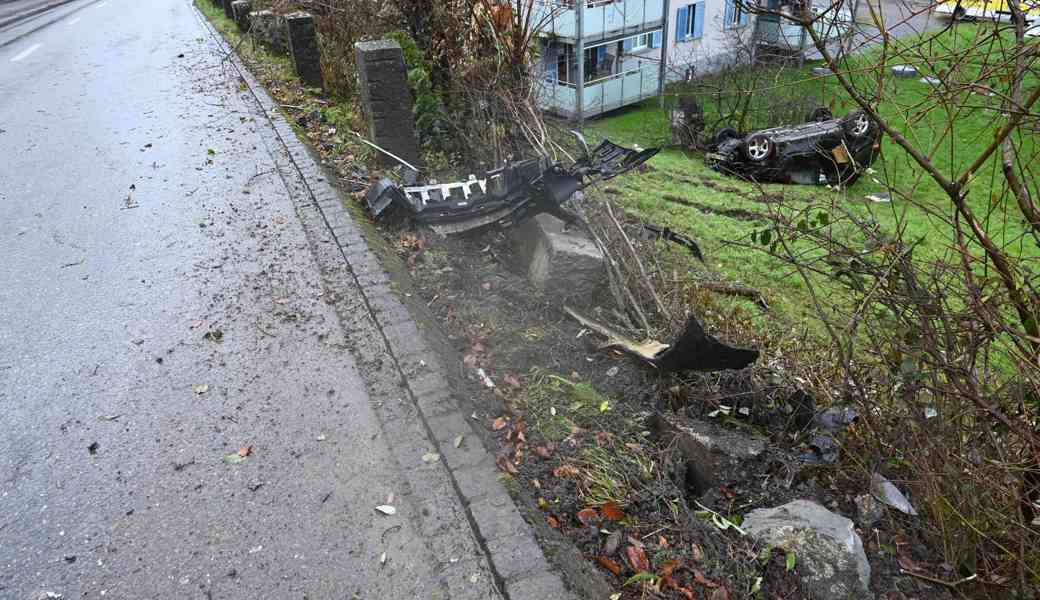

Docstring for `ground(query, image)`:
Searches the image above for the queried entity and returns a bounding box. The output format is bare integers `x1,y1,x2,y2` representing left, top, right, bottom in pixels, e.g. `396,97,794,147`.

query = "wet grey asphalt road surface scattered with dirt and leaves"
0,0,436,600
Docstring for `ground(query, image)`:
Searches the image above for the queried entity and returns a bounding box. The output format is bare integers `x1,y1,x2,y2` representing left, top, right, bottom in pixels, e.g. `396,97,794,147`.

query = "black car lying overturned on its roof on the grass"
705,108,880,185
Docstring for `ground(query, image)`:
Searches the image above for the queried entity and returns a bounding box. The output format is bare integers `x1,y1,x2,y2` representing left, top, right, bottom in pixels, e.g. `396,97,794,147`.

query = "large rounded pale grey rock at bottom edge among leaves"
742,500,874,600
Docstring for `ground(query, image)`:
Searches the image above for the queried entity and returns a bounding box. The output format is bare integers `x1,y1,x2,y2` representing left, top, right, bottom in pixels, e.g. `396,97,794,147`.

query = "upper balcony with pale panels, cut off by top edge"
528,0,665,42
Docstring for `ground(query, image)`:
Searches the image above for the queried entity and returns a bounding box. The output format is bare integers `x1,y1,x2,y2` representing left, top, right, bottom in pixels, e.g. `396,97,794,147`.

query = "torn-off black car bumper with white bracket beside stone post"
366,140,659,235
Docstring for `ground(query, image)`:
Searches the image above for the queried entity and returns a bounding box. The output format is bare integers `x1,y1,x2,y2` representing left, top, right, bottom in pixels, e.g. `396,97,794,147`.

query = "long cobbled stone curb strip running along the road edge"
192,8,575,600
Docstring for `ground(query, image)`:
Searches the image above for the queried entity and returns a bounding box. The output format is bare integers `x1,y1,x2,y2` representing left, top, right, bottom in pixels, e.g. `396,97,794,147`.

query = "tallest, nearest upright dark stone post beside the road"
355,40,419,166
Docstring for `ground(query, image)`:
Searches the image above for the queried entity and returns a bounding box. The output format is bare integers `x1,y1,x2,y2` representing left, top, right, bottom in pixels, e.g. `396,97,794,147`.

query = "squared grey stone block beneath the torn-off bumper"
510,213,607,305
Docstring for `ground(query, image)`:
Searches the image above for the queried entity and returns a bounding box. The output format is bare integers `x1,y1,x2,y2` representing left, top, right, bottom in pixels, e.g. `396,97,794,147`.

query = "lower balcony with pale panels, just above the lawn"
538,64,660,119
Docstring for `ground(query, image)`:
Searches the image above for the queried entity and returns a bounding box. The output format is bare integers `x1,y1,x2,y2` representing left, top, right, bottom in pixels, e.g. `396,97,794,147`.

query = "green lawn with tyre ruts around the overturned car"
586,25,1040,332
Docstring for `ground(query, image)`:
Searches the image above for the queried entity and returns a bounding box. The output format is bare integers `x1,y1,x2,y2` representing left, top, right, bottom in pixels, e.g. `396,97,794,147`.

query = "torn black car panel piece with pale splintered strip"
564,307,758,372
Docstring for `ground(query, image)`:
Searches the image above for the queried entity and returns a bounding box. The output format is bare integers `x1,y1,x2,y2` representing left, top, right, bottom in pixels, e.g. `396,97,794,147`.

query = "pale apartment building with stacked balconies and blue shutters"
532,0,754,120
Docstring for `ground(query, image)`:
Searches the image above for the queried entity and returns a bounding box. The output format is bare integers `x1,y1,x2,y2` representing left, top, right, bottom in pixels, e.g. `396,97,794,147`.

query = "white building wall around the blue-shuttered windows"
665,0,755,81
